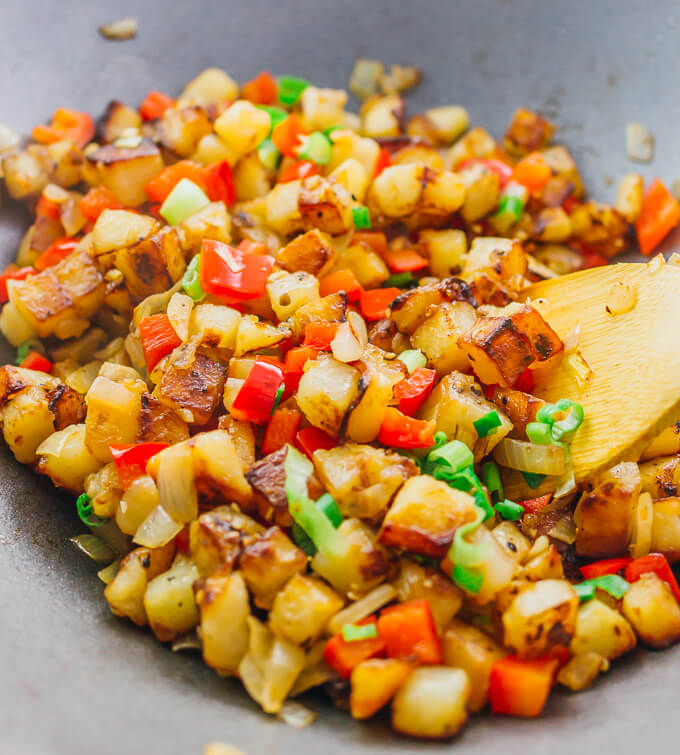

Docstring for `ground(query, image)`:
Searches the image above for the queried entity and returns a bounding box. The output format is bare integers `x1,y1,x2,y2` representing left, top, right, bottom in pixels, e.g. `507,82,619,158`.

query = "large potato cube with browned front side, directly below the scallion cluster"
378,475,476,558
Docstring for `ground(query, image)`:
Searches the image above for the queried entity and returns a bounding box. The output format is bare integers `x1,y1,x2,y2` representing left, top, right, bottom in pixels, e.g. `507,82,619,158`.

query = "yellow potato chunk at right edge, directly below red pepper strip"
622,573,680,649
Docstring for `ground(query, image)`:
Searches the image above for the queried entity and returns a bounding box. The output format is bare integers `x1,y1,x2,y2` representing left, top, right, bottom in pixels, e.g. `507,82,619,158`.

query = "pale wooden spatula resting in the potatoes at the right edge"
508,257,680,500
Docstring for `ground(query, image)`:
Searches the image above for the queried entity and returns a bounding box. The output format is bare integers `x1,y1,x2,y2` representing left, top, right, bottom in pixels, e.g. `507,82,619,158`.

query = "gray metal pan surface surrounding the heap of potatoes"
0,0,680,755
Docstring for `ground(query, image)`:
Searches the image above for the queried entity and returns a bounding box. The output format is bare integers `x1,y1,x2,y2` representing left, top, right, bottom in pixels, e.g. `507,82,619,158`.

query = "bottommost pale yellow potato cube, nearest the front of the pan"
392,666,470,739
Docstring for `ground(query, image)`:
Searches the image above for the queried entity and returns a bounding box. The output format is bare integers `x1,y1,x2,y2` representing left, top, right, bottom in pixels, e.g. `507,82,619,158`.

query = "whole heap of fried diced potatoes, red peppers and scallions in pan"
0,67,680,738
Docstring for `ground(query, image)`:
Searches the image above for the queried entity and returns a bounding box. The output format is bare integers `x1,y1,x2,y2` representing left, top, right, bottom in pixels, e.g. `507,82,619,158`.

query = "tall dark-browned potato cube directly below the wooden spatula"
574,462,640,558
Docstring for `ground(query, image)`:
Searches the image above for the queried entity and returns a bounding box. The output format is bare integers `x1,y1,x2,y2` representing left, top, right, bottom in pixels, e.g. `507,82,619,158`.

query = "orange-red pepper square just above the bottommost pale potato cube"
378,600,444,666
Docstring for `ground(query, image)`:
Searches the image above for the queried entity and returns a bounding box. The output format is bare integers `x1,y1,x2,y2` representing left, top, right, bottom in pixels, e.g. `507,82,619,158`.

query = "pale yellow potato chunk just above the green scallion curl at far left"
35,425,101,494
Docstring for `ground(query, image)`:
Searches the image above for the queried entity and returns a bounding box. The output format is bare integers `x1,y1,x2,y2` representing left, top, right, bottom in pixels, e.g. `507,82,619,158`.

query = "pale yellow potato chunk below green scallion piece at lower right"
569,600,637,661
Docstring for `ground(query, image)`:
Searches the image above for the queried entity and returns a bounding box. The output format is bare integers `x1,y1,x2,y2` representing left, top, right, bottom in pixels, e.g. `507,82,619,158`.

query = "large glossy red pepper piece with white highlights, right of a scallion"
199,239,274,302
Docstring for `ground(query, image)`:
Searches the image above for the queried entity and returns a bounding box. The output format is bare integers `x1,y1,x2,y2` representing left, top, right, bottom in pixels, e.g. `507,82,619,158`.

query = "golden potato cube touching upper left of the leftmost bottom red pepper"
269,574,344,645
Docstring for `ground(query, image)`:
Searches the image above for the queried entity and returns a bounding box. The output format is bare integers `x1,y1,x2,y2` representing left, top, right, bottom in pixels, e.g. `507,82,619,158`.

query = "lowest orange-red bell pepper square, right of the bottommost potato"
489,655,559,718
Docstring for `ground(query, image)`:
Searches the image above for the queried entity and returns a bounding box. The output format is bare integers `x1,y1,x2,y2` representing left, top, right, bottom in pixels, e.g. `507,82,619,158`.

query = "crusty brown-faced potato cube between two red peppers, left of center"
157,354,227,425
